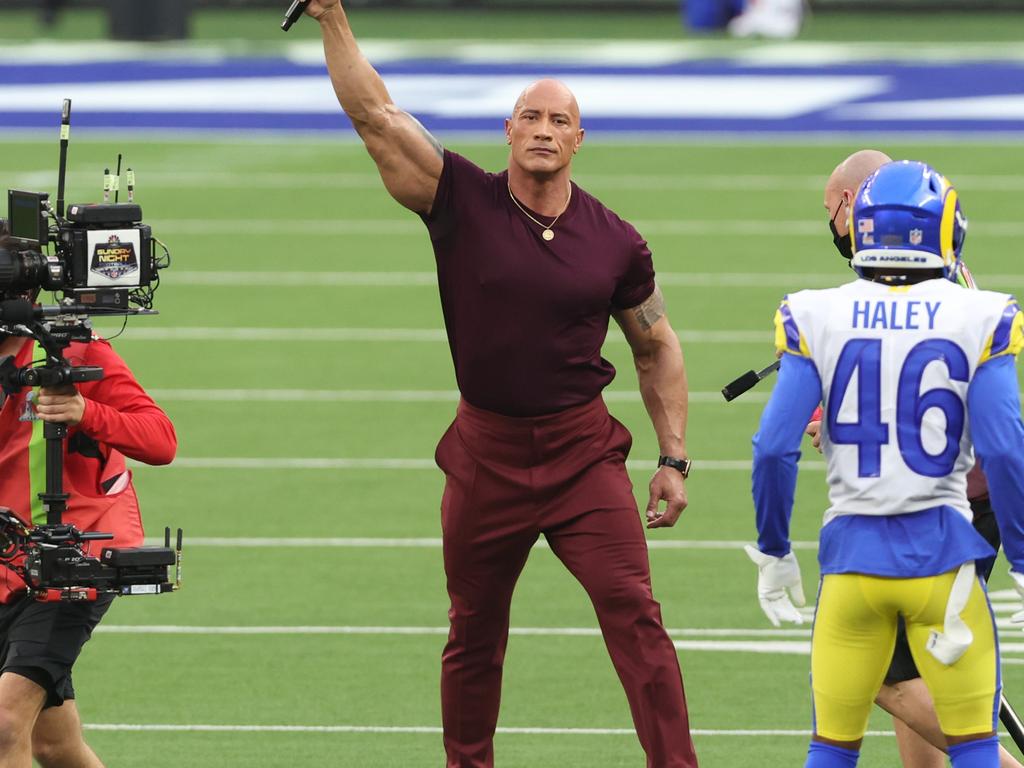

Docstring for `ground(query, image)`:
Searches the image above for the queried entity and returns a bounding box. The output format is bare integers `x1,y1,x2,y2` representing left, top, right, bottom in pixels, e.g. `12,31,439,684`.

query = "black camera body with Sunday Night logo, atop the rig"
0,189,159,313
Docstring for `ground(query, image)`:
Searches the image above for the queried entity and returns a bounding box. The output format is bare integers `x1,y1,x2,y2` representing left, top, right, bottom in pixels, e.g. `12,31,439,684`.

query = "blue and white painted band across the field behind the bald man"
0,57,1024,136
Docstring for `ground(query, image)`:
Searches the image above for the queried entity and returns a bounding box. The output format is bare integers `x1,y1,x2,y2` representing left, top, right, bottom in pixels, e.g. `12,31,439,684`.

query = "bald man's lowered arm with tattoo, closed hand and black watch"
613,286,687,528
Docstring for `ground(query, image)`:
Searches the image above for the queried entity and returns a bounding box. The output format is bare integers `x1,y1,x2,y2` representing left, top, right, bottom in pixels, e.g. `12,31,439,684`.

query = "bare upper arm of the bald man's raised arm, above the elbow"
356,104,444,214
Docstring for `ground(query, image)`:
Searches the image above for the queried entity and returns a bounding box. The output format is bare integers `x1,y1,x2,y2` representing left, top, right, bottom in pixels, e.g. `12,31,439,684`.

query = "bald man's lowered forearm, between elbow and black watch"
634,334,688,458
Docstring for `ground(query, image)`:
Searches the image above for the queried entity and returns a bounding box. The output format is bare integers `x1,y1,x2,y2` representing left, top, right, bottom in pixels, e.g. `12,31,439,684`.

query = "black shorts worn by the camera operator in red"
0,595,114,709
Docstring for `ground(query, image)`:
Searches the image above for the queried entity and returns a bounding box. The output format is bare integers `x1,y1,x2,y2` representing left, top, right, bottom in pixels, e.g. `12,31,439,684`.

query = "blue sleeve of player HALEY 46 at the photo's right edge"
967,355,1024,573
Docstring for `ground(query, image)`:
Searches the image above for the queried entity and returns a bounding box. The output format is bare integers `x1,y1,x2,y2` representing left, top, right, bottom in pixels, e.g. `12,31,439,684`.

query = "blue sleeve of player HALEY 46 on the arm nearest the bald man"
753,354,821,557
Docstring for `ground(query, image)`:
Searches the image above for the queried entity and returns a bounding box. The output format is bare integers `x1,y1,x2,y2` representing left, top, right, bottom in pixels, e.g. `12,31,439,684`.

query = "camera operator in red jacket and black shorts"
0,232,177,768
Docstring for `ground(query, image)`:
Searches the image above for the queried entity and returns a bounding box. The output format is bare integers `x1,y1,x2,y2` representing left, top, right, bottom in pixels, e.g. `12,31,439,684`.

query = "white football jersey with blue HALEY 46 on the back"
775,280,1024,523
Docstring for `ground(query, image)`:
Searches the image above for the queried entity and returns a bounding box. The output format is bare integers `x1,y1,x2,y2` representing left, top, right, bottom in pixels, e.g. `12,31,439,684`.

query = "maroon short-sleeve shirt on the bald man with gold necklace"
423,152,654,417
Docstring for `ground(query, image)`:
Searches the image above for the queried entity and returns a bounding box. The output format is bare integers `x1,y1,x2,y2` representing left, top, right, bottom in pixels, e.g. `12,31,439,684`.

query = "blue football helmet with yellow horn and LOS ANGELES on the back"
850,160,967,281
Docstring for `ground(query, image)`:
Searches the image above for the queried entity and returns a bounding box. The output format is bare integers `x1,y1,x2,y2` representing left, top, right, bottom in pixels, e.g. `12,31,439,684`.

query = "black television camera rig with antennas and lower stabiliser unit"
0,99,181,601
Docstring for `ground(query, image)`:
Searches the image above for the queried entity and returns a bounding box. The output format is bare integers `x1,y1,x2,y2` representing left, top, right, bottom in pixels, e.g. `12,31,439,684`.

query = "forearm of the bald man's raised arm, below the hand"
318,5,394,135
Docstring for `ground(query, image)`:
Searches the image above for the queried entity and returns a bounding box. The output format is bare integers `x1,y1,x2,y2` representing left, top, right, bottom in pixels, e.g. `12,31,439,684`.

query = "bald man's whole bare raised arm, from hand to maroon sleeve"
306,0,443,213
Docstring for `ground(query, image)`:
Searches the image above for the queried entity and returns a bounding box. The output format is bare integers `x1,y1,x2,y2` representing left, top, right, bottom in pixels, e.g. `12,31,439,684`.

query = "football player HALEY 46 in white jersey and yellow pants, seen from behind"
748,161,1024,768
